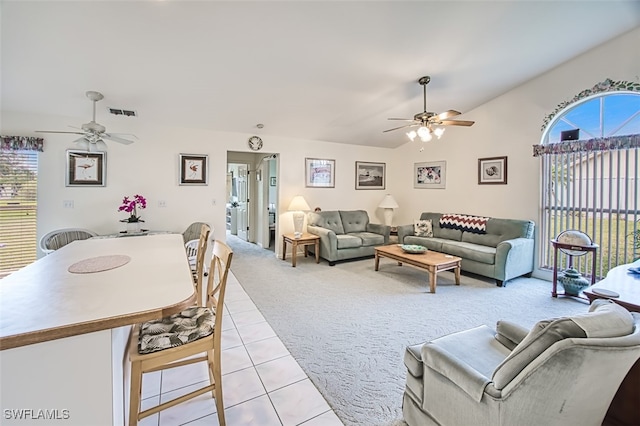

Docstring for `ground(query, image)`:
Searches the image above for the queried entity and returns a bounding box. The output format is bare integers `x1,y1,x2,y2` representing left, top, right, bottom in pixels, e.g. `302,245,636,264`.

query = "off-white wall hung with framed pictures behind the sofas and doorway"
0,29,640,262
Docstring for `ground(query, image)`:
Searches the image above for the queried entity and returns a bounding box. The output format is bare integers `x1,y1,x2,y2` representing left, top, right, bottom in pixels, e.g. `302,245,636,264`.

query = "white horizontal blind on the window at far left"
0,150,38,278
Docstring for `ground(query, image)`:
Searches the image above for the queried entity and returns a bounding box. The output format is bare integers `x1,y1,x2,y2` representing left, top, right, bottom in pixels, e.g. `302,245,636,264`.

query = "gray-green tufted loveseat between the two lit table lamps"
307,210,391,266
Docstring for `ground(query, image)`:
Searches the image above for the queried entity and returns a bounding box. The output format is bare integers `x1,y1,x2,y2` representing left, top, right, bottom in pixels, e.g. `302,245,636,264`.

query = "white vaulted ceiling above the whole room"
0,0,640,147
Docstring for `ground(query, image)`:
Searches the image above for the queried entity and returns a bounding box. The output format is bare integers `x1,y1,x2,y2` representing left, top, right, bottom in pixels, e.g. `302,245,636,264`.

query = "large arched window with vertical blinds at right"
534,80,640,277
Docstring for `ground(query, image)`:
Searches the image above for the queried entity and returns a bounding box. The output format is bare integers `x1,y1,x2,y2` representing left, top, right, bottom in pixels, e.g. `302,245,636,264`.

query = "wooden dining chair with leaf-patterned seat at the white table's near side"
127,241,233,426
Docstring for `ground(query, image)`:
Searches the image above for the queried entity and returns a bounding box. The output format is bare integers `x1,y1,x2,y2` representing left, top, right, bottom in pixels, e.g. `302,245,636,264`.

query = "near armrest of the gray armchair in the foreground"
422,342,491,402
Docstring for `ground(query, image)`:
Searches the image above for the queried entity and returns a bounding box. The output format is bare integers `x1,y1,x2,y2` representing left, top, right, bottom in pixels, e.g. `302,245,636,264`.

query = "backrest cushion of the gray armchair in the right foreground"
493,299,634,389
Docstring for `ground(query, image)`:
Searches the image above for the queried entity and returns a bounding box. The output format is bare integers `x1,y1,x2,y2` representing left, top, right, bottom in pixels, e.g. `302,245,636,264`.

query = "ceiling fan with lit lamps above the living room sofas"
383,76,475,142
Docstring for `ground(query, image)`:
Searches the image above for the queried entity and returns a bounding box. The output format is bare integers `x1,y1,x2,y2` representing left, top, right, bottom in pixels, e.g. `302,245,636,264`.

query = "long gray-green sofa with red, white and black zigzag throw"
398,212,535,287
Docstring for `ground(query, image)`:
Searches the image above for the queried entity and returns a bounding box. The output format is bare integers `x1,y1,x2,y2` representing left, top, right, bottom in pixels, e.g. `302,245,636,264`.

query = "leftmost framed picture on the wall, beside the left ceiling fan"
65,149,107,186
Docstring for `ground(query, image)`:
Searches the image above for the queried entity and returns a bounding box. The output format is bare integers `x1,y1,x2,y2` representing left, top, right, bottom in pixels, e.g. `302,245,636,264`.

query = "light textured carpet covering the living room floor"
227,235,588,426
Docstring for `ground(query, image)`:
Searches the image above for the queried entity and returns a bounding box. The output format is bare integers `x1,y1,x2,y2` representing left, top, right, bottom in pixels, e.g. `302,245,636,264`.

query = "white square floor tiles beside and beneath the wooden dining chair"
139,273,342,426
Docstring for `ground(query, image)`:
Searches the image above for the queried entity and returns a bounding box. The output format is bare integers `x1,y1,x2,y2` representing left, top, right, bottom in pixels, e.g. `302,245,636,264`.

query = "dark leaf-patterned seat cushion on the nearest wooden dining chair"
138,307,215,354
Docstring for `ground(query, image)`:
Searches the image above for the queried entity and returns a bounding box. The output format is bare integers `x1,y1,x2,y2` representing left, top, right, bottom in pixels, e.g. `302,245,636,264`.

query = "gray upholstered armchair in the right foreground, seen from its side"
403,299,640,426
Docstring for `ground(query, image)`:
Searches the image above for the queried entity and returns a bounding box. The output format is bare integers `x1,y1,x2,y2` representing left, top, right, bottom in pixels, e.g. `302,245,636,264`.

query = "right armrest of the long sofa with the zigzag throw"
495,238,535,281
